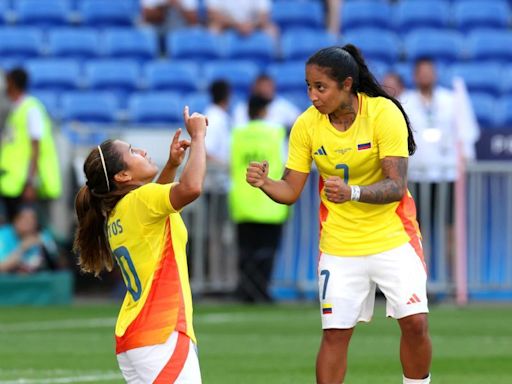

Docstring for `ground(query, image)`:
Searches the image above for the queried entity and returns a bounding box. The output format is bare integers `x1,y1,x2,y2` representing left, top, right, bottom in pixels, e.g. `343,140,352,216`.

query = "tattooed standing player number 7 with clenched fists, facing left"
246,45,431,384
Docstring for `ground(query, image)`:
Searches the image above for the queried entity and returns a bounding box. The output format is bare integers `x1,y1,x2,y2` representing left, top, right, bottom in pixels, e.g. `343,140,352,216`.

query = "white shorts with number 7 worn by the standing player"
318,243,428,329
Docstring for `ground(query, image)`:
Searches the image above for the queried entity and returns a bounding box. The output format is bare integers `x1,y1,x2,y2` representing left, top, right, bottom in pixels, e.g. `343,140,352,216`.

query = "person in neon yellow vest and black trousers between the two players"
229,95,288,302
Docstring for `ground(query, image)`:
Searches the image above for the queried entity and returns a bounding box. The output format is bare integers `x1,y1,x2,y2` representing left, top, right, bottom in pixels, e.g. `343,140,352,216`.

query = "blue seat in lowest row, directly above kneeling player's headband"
61,92,119,123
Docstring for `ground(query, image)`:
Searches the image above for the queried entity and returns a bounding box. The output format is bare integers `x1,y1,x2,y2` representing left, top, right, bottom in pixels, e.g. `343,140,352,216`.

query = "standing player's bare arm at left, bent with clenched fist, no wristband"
246,161,309,205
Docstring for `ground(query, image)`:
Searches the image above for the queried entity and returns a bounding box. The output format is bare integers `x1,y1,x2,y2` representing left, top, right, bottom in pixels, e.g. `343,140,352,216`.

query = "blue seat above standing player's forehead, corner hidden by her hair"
281,30,336,61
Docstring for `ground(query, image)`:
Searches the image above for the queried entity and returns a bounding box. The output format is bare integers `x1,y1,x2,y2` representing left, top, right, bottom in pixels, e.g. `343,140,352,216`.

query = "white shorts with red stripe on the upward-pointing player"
117,332,201,384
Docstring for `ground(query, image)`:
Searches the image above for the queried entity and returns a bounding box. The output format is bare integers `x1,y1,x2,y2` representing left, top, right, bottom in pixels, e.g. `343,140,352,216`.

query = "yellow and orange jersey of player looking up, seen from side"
107,183,195,353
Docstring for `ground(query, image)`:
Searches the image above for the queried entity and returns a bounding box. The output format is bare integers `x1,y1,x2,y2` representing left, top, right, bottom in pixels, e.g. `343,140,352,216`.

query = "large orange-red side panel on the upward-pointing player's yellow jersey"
116,218,187,354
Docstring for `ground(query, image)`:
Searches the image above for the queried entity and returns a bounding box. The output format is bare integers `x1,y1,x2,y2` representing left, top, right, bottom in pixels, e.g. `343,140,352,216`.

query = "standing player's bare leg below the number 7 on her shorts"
316,328,354,384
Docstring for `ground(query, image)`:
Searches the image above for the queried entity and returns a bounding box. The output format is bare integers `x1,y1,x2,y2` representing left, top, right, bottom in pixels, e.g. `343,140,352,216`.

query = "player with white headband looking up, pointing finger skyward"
75,107,207,384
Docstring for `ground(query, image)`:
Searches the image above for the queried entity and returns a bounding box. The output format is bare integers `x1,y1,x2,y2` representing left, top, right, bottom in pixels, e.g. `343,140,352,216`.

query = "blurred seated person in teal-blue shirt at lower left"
0,206,57,273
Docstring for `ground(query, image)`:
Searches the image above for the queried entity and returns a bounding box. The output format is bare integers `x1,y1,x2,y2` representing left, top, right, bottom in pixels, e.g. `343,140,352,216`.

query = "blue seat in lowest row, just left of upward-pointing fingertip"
128,92,183,125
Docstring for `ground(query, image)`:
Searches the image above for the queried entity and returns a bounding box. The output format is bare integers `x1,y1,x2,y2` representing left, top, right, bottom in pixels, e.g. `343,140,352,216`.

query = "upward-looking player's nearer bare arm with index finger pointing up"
169,107,207,210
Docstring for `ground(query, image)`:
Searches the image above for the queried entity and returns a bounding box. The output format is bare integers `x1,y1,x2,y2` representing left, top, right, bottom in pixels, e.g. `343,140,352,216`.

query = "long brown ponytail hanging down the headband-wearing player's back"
73,185,114,277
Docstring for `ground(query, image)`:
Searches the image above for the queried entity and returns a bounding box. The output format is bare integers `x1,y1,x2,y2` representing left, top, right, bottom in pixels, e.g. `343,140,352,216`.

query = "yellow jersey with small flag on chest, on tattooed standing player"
286,93,421,256
